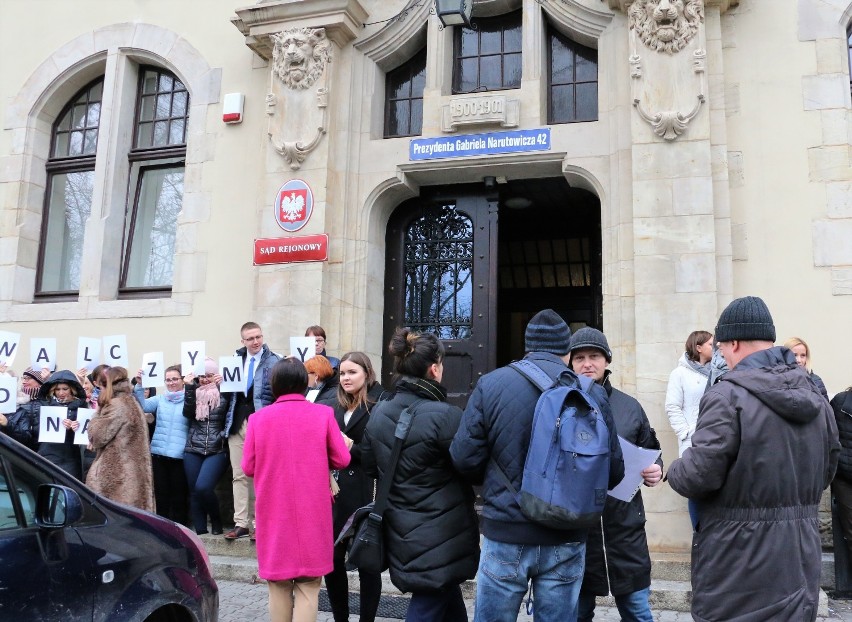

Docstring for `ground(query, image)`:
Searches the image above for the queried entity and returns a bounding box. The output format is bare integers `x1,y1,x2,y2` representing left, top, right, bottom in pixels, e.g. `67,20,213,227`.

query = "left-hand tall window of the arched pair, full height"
36,77,104,298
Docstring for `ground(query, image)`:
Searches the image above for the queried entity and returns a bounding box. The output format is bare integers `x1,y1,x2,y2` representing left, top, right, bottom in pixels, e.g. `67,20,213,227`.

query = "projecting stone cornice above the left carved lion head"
231,0,369,60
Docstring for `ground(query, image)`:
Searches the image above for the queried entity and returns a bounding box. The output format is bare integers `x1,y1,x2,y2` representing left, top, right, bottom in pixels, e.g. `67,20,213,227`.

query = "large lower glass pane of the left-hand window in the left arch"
40,171,95,292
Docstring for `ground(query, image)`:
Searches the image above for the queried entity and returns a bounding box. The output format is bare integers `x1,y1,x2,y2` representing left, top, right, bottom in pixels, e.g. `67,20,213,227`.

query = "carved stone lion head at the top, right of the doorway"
627,0,704,54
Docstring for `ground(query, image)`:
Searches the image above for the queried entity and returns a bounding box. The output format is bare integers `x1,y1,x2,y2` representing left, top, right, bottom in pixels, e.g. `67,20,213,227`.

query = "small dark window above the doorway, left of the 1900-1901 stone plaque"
385,48,426,138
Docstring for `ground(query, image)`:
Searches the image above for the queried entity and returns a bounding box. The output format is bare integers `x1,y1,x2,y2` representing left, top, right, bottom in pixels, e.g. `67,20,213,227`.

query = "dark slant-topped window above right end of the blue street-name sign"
547,28,598,124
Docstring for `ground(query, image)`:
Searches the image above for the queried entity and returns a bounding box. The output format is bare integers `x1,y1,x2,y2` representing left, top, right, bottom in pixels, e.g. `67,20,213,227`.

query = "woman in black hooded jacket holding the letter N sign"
35,369,86,481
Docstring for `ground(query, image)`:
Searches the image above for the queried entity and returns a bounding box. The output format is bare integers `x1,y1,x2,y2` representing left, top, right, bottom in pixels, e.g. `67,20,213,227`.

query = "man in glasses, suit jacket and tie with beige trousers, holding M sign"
225,322,280,540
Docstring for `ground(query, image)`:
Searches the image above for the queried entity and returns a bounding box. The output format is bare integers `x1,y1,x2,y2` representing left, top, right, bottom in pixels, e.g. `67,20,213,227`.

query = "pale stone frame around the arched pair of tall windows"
0,23,222,321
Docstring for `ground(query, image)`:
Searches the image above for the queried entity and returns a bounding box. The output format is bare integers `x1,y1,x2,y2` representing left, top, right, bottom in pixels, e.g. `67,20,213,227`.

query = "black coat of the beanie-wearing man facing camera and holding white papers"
582,372,663,596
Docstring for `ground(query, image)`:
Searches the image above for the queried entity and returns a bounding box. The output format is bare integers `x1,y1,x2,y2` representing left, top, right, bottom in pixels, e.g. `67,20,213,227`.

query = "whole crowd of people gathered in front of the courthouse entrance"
0,297,852,622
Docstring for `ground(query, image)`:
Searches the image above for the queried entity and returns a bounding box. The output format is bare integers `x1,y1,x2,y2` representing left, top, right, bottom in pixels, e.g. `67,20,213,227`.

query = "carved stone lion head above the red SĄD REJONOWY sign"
270,28,331,89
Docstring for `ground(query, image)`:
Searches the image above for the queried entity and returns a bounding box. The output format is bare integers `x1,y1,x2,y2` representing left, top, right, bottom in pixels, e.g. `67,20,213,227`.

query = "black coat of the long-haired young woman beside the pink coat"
332,383,384,540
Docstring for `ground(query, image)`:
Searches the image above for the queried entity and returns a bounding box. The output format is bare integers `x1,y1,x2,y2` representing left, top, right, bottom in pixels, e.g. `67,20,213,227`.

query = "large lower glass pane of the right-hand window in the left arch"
123,166,183,287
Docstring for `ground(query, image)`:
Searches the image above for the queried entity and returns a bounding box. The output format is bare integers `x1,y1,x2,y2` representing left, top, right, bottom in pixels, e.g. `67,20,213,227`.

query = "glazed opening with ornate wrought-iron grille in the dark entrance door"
404,205,473,339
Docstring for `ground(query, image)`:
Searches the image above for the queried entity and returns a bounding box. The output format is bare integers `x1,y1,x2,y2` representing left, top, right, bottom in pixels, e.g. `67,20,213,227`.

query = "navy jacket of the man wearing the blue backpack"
450,352,624,545
